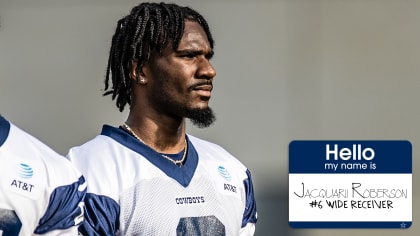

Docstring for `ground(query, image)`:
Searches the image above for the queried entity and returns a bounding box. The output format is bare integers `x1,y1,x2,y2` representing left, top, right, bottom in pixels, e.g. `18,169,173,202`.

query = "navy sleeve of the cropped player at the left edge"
34,176,86,235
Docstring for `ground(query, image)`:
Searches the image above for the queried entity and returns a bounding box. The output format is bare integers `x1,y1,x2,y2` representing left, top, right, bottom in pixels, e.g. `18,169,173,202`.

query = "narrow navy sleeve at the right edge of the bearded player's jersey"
240,170,257,235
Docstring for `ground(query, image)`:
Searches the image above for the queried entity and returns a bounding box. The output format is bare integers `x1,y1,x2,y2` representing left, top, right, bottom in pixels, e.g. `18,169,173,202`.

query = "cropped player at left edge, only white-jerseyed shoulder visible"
0,115,86,236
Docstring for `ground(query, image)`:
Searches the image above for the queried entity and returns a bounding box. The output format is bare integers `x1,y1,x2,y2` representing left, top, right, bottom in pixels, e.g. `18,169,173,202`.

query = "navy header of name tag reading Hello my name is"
289,140,412,174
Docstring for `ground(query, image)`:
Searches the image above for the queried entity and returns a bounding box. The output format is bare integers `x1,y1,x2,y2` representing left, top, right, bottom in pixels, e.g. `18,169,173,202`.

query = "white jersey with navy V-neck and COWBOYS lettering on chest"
68,125,257,236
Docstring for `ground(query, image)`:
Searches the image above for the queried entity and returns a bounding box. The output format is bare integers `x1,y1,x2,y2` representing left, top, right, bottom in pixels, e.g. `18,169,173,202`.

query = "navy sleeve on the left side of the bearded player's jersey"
79,193,120,236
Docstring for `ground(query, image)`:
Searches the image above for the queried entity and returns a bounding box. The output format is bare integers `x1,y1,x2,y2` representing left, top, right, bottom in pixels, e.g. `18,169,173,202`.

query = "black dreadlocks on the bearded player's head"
103,2,214,112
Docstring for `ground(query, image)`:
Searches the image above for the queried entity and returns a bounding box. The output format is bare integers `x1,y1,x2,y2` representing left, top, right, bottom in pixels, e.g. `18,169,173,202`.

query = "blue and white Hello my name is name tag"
289,140,412,228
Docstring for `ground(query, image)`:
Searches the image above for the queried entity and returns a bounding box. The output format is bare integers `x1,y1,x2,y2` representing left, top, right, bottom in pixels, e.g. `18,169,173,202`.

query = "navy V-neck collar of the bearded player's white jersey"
101,125,198,187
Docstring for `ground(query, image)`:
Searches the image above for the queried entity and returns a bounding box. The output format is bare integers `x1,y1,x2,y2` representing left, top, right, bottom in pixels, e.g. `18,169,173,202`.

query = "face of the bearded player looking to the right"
146,20,216,127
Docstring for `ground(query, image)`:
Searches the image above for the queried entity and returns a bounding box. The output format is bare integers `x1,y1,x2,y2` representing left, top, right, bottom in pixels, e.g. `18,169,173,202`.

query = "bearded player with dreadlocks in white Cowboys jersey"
68,3,257,236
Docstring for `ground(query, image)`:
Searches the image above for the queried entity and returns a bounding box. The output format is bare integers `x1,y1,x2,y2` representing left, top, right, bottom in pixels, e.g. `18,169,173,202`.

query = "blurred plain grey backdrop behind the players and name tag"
0,0,420,236
